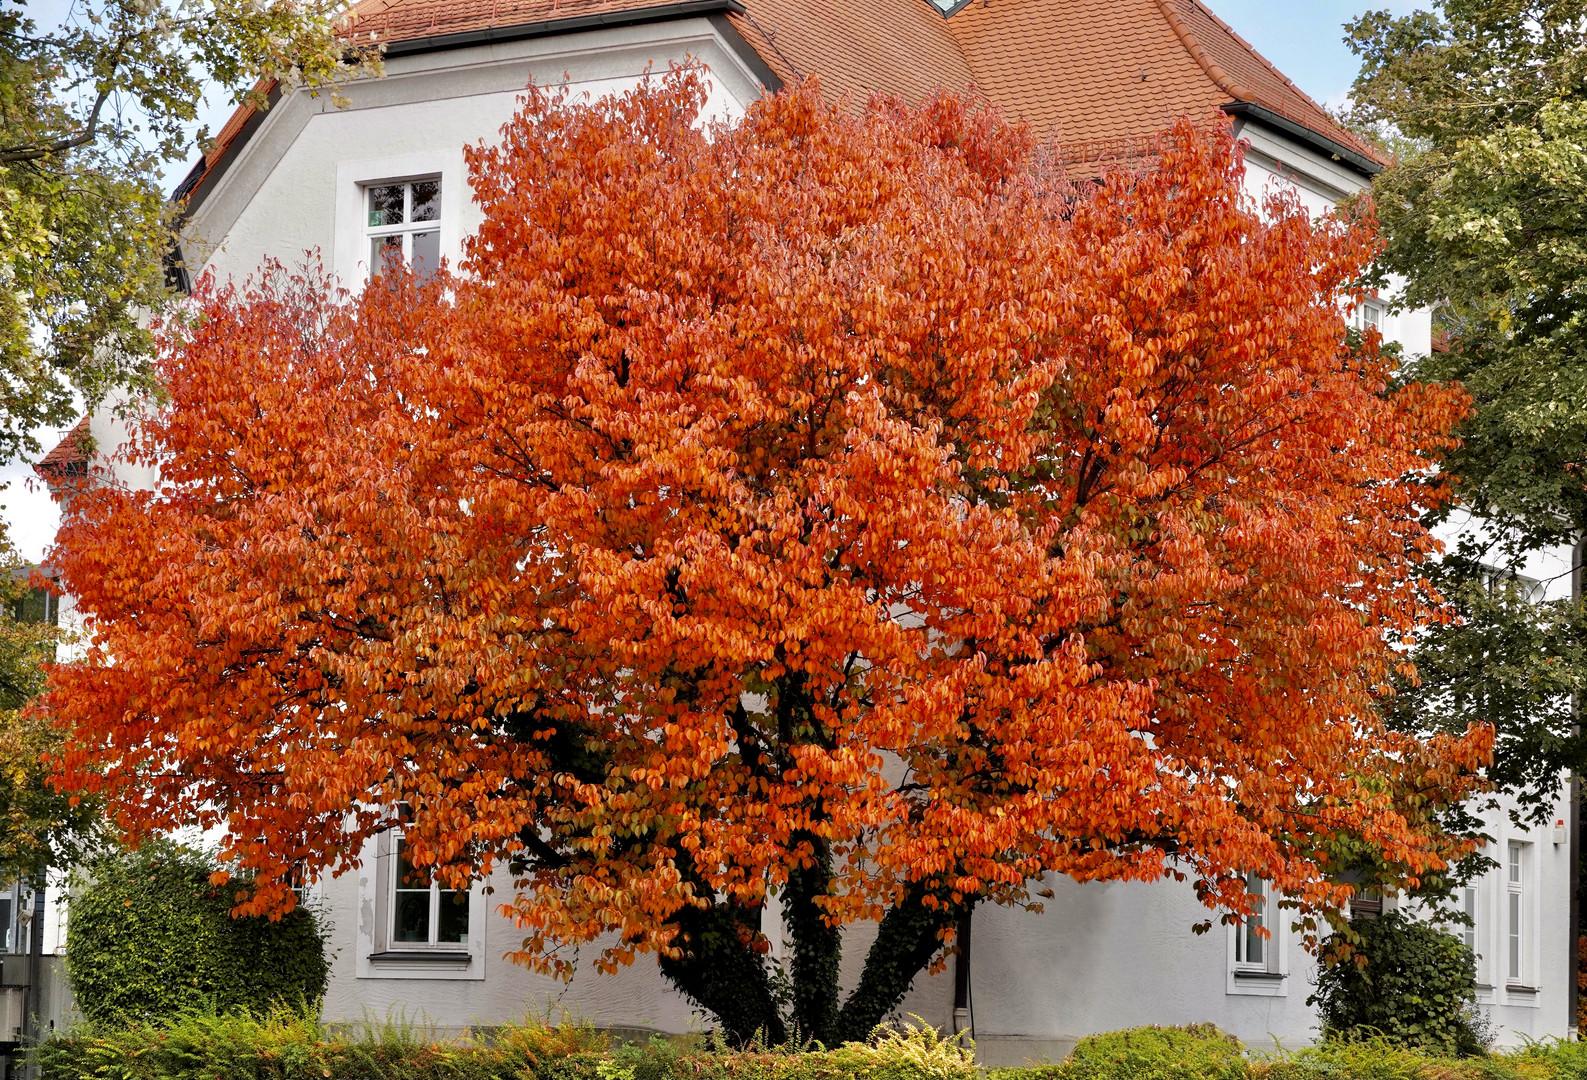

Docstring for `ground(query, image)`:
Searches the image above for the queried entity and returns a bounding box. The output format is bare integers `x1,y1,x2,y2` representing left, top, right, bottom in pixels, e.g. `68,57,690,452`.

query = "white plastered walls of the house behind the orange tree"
52,19,1571,1063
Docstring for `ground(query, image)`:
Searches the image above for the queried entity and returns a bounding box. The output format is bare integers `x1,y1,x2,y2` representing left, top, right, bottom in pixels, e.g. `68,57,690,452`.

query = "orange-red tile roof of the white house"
178,0,1387,212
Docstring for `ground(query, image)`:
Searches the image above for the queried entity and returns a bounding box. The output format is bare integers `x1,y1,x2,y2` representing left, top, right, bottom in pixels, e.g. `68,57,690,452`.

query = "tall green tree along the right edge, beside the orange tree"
1347,0,1587,818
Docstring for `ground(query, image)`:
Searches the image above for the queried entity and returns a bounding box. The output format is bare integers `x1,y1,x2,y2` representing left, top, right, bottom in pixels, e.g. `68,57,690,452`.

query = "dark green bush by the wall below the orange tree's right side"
1308,912,1484,1058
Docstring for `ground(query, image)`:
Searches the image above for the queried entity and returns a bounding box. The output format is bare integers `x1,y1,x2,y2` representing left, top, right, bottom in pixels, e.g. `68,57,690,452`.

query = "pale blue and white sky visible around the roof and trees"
0,0,1427,561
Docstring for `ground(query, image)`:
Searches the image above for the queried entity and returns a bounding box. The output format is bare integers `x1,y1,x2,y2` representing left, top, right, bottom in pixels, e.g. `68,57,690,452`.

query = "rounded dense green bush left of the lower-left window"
67,841,330,1023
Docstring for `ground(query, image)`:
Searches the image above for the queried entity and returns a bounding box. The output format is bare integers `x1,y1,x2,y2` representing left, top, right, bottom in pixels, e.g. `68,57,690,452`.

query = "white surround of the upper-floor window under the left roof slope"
330,147,470,292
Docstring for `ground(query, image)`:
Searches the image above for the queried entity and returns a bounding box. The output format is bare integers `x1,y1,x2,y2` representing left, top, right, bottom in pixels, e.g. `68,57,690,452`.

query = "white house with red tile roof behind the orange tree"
30,0,1576,1063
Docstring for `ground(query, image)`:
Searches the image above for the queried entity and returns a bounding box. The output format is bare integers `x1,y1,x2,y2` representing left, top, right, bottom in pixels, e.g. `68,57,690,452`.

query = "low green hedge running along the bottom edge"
33,1009,1587,1080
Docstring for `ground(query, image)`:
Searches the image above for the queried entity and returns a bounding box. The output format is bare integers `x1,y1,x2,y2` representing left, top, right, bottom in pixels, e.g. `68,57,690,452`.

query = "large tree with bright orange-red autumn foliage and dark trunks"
46,73,1489,1040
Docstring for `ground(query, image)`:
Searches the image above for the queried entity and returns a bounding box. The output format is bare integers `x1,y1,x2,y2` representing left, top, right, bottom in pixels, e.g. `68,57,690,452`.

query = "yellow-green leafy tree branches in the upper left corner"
0,0,367,458
